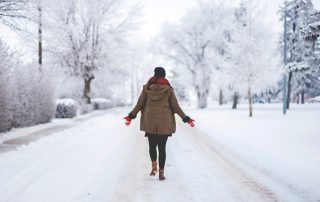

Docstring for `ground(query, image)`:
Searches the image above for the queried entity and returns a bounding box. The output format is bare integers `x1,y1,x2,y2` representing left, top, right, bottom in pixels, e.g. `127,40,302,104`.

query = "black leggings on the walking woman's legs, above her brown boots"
148,135,168,169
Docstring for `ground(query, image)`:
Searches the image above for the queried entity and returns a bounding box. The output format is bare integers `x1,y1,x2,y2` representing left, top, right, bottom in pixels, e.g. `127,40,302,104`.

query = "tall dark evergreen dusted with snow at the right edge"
283,0,319,106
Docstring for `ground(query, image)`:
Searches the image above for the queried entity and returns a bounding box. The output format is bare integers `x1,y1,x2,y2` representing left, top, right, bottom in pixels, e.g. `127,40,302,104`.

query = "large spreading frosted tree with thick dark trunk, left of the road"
49,0,137,103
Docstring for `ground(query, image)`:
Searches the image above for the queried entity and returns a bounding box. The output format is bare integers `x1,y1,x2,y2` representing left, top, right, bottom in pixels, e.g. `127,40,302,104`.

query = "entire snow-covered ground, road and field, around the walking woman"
0,104,320,202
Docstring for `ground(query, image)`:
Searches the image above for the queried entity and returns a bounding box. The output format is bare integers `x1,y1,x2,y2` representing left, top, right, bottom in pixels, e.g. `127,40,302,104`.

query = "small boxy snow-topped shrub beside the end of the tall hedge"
56,98,78,118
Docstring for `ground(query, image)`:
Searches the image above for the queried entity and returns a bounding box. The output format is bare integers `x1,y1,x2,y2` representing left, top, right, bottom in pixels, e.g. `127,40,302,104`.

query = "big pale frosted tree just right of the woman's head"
156,1,229,108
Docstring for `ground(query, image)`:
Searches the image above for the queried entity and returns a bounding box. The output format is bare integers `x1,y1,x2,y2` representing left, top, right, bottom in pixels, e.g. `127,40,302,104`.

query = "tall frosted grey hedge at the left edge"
0,41,55,132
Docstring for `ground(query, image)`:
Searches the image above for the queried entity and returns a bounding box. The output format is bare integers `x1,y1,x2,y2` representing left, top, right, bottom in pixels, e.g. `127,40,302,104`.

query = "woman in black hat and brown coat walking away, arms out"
124,67,194,180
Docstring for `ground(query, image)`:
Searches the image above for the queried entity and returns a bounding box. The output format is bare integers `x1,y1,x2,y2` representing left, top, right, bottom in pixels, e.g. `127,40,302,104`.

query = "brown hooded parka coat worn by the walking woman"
130,84,186,135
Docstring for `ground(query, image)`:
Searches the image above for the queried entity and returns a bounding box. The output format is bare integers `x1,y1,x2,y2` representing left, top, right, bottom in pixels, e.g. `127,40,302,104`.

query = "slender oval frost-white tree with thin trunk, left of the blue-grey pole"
227,1,281,117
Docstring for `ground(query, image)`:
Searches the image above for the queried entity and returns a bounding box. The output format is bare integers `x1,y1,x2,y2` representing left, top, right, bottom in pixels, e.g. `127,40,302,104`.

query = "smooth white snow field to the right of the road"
190,105,320,201
